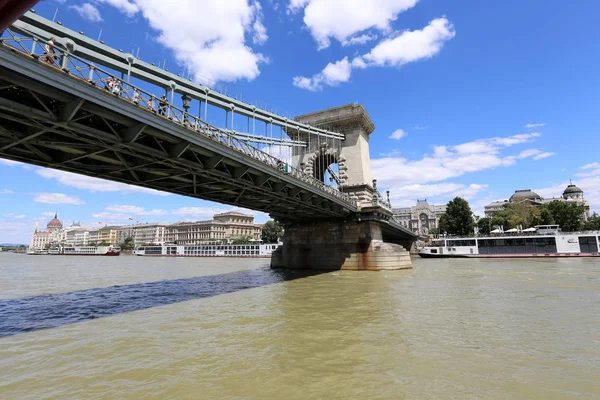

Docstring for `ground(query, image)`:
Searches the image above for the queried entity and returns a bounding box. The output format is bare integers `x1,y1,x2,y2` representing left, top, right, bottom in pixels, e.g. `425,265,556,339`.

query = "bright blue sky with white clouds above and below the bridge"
0,0,600,243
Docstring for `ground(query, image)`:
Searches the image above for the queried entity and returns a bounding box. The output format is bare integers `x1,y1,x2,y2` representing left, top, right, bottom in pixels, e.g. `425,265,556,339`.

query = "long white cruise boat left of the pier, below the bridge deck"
133,244,280,258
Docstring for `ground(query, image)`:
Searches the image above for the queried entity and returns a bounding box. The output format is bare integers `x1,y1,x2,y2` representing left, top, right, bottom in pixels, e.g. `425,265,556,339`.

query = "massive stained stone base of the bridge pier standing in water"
271,221,412,271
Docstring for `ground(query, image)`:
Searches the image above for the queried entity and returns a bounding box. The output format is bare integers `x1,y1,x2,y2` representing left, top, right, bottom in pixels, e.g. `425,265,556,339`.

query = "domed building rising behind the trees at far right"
484,183,590,221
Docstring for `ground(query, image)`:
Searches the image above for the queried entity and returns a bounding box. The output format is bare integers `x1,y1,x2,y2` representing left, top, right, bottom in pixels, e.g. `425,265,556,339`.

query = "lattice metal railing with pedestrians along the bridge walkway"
0,28,358,207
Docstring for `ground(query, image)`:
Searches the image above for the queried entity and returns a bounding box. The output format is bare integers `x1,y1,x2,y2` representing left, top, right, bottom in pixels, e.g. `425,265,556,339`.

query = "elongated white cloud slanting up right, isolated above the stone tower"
292,17,456,91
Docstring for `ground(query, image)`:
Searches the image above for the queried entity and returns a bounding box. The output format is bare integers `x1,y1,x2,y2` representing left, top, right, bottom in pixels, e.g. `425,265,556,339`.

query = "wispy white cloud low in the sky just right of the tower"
371,133,539,188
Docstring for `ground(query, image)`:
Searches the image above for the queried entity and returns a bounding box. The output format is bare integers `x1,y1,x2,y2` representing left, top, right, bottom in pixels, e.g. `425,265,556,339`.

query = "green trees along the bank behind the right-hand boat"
430,197,600,236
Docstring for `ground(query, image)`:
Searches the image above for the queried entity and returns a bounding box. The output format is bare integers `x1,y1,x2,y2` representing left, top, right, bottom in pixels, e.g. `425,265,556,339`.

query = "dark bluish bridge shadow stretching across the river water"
0,269,325,337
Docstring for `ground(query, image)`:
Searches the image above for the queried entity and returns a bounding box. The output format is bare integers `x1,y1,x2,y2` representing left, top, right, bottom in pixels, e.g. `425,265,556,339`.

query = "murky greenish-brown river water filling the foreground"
0,253,600,400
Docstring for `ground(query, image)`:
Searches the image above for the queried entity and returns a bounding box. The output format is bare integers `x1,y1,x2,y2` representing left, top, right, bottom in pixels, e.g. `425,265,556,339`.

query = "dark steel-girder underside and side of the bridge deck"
0,49,356,220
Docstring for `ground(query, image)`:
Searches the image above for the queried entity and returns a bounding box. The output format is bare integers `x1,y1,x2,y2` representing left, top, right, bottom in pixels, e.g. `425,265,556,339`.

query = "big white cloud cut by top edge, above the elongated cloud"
288,0,418,49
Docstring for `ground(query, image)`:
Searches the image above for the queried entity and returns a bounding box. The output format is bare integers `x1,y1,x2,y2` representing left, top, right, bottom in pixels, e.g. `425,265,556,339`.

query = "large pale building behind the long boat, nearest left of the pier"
166,212,262,244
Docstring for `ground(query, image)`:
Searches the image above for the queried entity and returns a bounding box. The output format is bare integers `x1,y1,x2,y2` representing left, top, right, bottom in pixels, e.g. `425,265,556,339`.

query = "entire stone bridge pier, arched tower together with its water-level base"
271,104,415,271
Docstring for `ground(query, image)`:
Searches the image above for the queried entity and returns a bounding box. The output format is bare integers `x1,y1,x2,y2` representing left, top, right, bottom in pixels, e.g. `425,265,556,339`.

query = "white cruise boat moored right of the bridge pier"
418,225,600,258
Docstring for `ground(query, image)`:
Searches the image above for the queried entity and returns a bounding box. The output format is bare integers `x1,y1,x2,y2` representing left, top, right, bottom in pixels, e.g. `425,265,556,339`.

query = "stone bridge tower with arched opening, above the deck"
288,104,376,205
